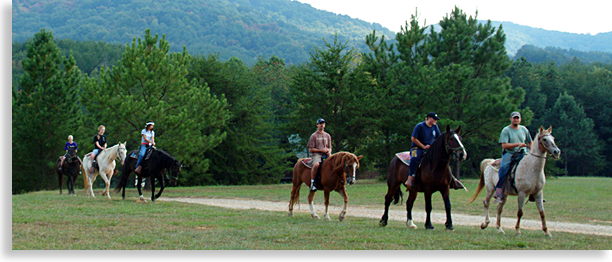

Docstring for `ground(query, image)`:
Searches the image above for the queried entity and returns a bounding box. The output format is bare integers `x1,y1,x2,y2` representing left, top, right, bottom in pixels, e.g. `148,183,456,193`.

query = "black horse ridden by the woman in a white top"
115,149,181,202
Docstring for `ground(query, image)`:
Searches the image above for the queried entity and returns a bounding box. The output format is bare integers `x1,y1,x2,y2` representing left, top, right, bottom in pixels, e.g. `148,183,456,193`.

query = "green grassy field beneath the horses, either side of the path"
12,178,612,249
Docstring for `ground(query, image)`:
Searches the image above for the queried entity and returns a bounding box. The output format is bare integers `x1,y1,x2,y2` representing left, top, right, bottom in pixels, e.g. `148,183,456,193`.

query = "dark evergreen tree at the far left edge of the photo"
12,29,81,193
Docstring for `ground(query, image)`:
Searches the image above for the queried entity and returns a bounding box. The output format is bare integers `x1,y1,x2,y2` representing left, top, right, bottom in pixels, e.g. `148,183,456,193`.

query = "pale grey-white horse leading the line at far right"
468,126,561,237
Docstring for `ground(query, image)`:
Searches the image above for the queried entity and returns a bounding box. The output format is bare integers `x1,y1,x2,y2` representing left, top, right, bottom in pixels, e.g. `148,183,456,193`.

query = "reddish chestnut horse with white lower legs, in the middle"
289,152,363,221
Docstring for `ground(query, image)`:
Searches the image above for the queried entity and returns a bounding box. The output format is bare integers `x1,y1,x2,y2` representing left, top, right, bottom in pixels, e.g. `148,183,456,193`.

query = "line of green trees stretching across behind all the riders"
11,8,612,193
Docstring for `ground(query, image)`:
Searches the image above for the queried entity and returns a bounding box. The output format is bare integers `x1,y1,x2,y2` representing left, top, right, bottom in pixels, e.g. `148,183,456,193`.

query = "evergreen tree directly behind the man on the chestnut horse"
289,36,378,158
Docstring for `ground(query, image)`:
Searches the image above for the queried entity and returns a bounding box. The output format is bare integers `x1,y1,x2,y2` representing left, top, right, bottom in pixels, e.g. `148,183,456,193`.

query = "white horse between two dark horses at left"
82,141,127,199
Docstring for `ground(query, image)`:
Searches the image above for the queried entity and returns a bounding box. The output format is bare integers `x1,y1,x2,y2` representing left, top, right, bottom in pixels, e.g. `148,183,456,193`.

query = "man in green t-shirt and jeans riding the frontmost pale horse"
494,111,533,203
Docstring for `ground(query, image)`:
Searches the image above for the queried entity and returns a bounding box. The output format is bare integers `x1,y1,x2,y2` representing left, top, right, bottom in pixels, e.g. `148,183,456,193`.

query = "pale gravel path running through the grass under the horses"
159,197,612,236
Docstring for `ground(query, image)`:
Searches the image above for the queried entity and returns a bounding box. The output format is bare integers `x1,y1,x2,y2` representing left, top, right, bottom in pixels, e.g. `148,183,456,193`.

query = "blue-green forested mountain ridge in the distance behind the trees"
11,0,612,64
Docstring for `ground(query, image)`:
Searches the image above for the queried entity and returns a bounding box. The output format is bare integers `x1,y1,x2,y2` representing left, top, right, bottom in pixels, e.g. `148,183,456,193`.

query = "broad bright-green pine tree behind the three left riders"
83,29,229,185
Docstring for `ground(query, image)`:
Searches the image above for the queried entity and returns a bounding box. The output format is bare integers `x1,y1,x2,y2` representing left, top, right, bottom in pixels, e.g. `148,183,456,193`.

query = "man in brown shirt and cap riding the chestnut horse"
308,118,331,191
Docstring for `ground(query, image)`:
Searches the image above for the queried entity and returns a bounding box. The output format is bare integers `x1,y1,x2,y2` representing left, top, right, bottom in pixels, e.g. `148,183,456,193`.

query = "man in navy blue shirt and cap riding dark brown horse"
405,112,442,187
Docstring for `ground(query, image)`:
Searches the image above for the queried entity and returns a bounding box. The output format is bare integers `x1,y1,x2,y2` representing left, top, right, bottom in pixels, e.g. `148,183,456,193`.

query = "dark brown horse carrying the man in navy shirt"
379,125,467,230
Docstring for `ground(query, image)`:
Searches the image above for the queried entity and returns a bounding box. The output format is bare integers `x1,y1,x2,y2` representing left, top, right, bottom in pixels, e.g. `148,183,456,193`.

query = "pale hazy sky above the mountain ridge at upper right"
298,0,612,35
